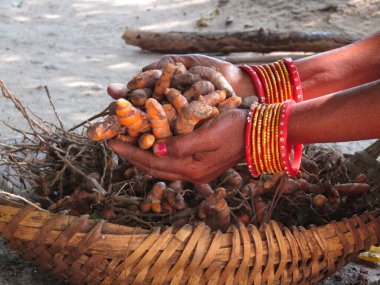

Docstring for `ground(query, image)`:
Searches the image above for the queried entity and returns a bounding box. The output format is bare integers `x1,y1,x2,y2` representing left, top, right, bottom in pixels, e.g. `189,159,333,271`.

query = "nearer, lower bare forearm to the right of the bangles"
288,80,380,144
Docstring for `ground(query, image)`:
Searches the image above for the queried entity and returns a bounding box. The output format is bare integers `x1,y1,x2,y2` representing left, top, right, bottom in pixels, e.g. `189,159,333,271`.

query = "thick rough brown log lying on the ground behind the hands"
123,28,359,53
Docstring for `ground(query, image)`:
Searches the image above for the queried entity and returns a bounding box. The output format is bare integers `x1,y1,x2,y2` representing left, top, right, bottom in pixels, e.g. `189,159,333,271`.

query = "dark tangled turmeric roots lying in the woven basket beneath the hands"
47,144,371,231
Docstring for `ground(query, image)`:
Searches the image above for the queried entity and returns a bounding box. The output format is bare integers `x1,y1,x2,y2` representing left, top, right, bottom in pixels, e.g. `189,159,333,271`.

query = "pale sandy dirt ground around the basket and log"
0,0,380,285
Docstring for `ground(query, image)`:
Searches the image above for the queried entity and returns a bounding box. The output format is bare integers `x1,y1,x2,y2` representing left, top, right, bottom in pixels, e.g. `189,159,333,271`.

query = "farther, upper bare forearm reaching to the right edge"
296,32,380,100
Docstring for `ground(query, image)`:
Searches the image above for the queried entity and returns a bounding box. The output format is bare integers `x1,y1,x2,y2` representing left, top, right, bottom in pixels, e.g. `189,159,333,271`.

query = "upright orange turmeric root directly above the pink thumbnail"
145,98,172,139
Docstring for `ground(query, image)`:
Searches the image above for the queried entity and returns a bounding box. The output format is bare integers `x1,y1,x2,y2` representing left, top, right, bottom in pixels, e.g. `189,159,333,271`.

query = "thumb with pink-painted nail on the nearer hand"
153,131,217,158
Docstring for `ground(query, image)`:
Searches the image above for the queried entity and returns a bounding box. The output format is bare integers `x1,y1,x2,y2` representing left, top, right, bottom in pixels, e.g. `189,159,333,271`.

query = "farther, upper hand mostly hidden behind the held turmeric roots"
107,54,256,99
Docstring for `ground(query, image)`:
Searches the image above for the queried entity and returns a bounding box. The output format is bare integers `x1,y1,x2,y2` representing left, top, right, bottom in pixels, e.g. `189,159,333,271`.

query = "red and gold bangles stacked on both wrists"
240,58,303,176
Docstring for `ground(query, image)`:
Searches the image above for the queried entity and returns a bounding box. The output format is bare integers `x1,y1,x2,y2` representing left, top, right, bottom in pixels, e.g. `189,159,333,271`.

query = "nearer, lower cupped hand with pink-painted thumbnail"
108,109,248,183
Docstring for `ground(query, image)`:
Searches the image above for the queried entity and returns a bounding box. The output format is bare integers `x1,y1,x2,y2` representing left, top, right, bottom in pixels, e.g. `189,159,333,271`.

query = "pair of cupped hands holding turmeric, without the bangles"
107,55,254,183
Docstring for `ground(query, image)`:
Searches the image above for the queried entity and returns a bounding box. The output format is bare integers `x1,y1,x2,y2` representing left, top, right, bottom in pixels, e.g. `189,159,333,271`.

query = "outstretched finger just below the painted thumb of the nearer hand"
108,140,183,174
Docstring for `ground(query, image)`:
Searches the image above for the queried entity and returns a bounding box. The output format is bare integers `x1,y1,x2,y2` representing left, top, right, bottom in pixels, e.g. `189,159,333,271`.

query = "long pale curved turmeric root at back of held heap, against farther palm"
189,66,236,97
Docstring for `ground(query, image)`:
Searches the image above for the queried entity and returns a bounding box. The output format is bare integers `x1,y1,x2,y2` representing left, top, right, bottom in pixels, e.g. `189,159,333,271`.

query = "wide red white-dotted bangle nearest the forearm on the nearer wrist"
278,100,302,176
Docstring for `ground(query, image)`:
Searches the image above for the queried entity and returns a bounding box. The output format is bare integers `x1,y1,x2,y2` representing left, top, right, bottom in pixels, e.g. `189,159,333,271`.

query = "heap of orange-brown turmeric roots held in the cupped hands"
87,63,242,149
